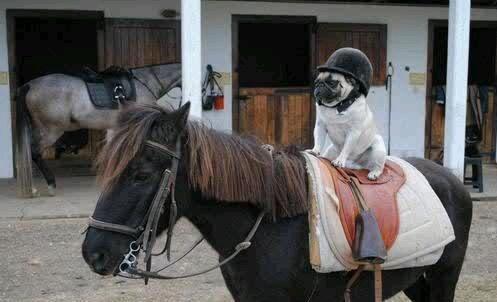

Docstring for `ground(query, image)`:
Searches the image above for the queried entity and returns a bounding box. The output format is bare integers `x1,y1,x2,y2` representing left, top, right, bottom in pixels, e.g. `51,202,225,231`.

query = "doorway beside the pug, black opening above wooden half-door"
232,16,316,147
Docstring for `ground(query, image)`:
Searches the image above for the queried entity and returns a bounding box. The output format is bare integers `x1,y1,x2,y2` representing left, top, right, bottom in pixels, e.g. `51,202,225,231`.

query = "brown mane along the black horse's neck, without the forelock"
186,122,307,217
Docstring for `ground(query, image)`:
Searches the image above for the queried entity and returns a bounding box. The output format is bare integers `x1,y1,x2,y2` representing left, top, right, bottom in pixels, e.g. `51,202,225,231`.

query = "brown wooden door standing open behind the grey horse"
89,19,181,157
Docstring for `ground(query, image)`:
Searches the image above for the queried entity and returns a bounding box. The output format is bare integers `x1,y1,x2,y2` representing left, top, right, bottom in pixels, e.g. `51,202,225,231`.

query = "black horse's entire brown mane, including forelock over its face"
97,106,308,217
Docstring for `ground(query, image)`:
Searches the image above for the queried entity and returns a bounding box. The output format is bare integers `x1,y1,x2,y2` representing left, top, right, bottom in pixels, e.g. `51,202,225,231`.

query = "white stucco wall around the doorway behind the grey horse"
0,0,180,178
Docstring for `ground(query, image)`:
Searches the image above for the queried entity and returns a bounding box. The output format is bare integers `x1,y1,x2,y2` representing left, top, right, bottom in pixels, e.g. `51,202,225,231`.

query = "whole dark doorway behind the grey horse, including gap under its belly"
7,10,104,175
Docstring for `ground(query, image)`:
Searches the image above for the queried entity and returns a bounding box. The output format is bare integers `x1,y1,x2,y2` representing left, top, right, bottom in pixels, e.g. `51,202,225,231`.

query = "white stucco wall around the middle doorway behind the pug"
202,1,497,157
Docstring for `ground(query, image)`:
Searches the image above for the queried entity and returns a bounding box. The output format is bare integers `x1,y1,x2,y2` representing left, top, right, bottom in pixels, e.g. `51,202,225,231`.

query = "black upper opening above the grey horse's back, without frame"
15,17,98,85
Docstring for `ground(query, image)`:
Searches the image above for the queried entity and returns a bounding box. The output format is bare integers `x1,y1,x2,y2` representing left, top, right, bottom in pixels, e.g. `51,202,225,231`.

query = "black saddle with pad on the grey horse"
79,66,136,109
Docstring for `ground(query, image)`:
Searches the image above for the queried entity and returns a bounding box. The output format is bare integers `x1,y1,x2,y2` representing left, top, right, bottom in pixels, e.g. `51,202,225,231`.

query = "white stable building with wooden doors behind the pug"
0,0,497,189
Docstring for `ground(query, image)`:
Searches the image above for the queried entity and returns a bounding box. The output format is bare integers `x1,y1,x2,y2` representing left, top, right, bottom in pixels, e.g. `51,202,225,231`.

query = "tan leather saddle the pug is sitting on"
319,158,406,251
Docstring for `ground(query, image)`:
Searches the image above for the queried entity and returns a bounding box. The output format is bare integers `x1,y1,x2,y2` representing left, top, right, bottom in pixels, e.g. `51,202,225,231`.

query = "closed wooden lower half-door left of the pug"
239,88,314,147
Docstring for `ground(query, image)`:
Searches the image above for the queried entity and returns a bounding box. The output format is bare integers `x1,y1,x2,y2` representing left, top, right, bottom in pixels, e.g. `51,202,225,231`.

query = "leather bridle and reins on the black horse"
88,138,265,284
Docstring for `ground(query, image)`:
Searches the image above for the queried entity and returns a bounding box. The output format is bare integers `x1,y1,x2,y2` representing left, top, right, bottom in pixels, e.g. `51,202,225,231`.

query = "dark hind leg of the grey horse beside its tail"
31,128,64,196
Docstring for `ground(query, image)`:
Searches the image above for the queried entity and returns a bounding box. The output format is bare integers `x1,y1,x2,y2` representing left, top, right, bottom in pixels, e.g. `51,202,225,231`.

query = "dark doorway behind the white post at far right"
425,20,497,161
